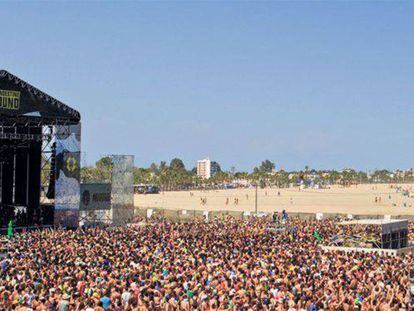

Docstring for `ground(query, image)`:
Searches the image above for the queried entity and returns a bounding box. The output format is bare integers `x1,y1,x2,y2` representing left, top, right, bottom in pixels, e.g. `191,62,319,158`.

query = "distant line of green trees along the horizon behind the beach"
81,157,414,191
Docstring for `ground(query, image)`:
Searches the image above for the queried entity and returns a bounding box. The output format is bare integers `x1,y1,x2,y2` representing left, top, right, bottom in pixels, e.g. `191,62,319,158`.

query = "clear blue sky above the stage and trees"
0,1,414,170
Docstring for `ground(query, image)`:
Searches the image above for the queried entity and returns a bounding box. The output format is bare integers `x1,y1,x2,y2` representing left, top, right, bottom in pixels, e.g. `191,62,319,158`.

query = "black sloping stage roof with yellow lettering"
0,70,81,125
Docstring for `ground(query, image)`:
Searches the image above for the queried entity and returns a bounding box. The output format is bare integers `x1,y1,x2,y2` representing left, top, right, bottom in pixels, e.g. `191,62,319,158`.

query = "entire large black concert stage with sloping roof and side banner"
0,70,81,232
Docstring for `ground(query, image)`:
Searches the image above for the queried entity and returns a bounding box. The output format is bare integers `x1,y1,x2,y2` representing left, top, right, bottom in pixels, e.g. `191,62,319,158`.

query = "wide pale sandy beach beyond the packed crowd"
135,184,414,216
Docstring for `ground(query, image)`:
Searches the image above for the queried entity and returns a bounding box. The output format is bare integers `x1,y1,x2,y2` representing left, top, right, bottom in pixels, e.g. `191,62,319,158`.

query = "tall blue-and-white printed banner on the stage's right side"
55,124,81,227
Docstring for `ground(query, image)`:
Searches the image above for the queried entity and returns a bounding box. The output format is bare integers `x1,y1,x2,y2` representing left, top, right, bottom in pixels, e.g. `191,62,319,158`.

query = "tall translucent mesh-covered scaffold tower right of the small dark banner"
111,155,134,224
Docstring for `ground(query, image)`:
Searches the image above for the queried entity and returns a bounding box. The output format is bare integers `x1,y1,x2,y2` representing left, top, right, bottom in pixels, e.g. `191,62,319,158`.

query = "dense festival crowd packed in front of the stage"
0,217,414,311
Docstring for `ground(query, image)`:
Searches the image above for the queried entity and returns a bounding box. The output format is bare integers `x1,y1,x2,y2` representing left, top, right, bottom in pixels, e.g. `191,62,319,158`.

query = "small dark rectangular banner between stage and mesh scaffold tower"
79,183,111,211
